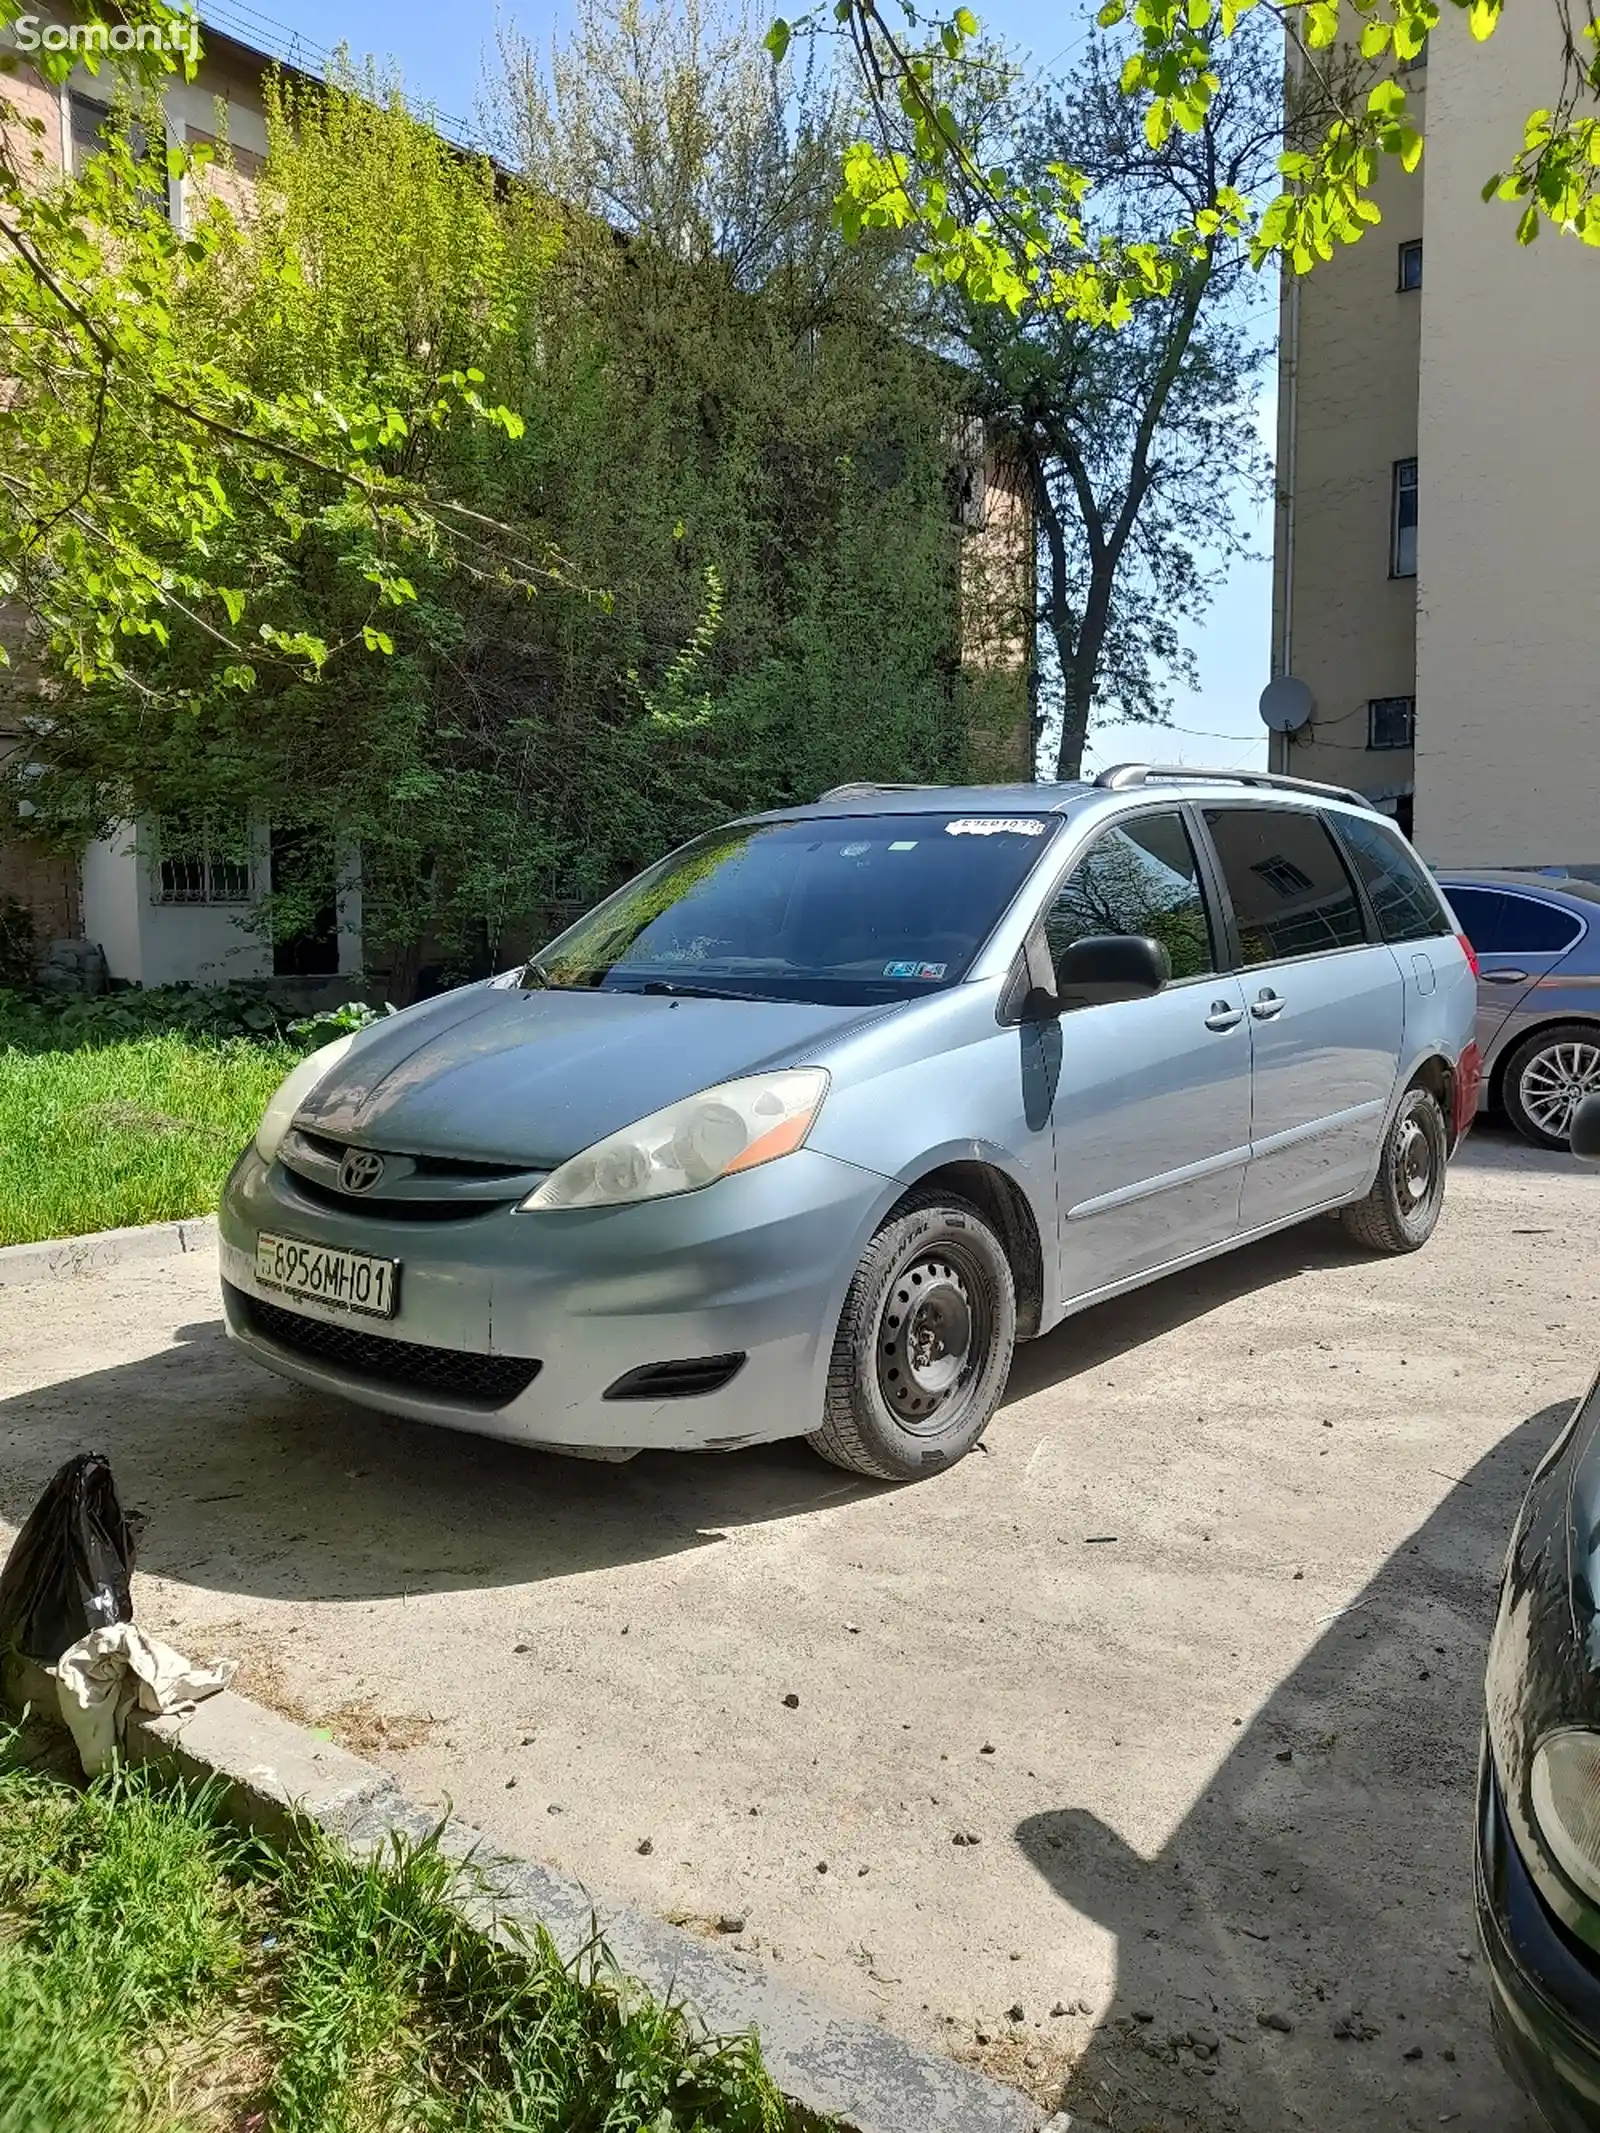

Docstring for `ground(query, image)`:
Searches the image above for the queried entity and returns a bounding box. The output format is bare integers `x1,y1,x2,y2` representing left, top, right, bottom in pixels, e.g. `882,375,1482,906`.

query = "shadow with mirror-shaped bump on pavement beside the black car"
1018,1401,1570,2133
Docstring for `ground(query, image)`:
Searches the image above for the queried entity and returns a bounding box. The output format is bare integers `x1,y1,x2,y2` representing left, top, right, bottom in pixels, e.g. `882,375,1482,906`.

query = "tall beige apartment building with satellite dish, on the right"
1263,11,1600,877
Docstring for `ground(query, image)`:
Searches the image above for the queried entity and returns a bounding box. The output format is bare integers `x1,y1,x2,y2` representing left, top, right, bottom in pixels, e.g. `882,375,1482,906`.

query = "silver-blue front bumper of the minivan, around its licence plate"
218,1150,900,1450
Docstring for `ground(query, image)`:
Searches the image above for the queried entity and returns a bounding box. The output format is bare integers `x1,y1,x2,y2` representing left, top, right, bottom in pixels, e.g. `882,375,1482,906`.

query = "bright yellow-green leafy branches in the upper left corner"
0,0,548,691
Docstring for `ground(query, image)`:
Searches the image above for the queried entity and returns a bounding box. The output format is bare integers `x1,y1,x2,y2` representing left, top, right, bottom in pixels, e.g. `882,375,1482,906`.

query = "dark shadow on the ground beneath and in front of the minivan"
0,1222,1350,1600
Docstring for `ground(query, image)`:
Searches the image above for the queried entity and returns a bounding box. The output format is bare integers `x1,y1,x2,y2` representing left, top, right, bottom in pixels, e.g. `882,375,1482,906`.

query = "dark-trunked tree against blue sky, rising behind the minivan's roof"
943,34,1282,779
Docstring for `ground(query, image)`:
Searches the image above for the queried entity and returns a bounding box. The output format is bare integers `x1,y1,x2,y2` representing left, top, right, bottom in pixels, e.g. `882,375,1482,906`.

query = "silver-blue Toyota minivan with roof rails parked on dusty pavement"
220,764,1478,1480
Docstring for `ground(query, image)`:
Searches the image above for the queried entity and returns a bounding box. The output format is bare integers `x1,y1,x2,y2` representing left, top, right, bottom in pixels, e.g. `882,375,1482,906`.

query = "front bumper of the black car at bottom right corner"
1474,1749,1600,2133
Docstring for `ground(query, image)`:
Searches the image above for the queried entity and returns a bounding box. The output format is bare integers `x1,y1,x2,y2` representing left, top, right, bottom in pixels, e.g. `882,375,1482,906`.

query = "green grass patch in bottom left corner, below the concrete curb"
0,1741,787,2133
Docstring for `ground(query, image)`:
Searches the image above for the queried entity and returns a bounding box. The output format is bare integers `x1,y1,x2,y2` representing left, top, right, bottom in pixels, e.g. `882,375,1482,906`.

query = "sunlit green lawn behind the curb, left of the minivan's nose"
0,1020,299,1244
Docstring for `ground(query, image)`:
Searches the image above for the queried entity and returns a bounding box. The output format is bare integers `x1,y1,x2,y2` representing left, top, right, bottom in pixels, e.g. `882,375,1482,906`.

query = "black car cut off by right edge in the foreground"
1476,1096,1600,2133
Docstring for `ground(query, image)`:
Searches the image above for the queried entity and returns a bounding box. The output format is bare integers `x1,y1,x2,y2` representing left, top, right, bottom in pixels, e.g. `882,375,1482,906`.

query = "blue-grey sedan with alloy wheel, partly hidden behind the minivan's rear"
1438,870,1600,1148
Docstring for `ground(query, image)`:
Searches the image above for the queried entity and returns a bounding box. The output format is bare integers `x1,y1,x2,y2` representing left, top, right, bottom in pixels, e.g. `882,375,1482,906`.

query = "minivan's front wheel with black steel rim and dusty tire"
806,1192,1018,1480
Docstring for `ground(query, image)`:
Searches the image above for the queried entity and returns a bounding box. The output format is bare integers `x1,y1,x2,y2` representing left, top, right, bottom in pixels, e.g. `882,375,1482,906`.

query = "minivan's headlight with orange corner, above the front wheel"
521,1067,828,1212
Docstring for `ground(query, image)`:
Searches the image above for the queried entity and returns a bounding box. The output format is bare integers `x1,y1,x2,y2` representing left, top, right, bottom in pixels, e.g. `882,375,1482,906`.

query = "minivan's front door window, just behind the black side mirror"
1045,813,1216,979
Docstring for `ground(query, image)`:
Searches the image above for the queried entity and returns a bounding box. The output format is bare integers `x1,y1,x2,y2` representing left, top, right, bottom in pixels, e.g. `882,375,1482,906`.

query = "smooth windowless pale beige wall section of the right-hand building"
1417,9,1600,868
